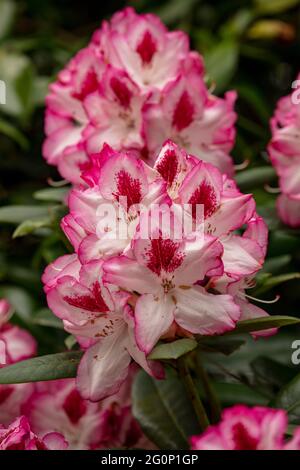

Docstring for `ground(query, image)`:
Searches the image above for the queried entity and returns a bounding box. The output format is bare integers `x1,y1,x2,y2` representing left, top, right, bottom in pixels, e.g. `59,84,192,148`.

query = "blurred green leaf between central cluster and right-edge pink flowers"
236,166,276,191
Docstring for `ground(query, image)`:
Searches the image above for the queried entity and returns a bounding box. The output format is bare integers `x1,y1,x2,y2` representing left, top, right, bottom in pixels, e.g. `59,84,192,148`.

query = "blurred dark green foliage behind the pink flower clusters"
0,0,300,416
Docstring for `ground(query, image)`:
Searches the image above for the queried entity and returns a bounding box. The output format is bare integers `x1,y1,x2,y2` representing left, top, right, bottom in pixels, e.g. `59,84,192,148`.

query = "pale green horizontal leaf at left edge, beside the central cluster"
0,205,49,224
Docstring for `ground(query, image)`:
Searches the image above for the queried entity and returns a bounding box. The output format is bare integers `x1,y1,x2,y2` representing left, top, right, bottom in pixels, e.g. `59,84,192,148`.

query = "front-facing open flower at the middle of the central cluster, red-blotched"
104,206,240,354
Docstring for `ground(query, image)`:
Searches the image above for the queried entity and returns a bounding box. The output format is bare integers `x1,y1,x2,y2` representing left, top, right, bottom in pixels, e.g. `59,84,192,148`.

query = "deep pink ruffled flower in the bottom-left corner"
0,416,68,450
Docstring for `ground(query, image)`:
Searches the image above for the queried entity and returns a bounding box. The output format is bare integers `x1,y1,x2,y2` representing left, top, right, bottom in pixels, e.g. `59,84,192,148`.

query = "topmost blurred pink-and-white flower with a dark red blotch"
92,8,189,90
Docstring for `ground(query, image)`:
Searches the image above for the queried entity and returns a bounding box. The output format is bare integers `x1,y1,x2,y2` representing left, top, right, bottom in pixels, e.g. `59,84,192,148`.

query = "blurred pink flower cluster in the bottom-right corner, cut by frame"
191,405,300,450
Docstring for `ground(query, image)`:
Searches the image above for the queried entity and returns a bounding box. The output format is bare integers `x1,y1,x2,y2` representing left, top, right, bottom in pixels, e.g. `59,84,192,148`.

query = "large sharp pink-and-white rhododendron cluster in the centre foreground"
43,141,274,400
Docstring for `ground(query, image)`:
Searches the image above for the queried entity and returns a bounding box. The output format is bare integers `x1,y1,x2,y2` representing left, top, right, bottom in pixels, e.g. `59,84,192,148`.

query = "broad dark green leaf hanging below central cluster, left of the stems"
132,369,200,450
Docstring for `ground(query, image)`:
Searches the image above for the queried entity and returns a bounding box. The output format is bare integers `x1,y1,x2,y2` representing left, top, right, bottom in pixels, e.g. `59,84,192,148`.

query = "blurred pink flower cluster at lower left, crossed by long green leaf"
0,299,146,450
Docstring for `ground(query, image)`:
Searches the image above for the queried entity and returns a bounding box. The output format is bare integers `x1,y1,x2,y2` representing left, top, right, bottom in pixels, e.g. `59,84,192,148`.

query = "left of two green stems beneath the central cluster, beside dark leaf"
178,356,209,431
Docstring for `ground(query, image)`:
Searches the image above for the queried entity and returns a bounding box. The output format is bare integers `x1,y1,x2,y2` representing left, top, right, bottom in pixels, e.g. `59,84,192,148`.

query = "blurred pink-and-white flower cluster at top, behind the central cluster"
43,8,236,184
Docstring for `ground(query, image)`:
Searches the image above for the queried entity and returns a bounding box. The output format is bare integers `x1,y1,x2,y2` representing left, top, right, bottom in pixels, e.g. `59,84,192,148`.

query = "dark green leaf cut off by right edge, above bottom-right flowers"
271,374,300,424
